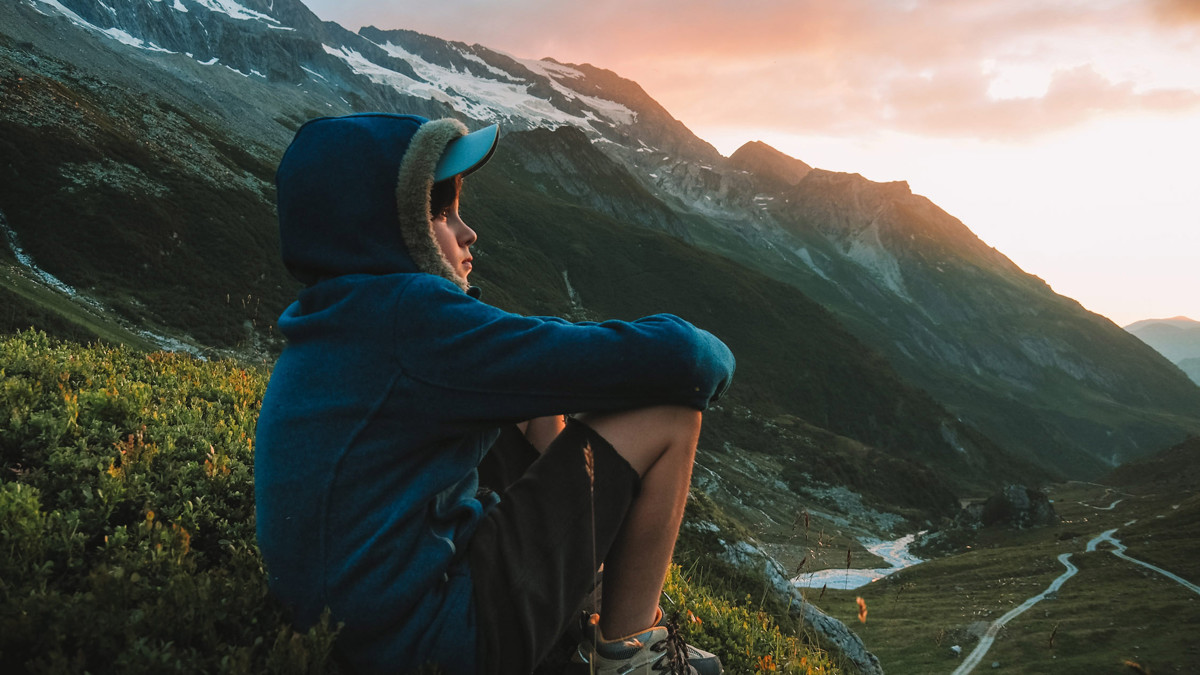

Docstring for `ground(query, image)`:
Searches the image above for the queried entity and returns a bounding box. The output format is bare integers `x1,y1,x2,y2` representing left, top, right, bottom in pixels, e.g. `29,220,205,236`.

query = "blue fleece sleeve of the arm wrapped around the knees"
395,271,734,423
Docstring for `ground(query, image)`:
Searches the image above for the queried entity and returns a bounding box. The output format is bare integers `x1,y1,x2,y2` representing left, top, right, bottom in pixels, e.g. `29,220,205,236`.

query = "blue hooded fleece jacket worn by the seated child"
254,114,734,674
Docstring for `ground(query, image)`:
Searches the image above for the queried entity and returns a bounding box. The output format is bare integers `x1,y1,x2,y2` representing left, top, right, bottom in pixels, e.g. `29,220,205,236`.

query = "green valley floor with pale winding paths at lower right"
806,483,1200,674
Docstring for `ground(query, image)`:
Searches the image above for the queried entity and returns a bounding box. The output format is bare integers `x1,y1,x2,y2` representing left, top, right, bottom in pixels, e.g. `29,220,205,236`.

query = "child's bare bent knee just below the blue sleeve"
576,406,701,476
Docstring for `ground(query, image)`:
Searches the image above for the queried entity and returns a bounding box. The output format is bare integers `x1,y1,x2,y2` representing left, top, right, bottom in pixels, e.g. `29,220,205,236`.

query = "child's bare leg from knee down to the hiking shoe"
578,406,701,639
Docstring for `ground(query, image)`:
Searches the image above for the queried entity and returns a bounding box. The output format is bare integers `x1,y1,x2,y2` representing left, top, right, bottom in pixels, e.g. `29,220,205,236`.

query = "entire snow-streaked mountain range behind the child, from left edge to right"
0,0,1200,519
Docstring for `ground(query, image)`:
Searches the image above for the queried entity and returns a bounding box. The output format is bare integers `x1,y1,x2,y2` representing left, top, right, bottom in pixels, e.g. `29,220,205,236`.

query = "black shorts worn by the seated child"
467,419,641,674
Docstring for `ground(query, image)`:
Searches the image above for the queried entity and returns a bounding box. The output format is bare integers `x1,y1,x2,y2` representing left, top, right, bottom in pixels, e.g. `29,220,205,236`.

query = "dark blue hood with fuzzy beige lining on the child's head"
275,113,467,291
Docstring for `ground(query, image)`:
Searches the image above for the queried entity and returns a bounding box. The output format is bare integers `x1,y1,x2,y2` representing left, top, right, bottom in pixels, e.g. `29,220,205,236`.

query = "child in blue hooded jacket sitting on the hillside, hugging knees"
254,113,734,674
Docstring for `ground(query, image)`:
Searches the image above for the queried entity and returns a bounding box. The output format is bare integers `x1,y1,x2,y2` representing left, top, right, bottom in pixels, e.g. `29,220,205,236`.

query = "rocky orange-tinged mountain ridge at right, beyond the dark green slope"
753,171,1200,477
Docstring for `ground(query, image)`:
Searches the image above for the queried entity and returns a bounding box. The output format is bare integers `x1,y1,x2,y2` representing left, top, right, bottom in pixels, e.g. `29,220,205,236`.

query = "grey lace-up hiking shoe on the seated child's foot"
564,625,725,675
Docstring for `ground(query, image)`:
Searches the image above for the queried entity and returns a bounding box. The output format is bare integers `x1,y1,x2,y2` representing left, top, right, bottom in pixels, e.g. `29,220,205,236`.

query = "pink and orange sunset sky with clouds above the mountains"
309,0,1200,139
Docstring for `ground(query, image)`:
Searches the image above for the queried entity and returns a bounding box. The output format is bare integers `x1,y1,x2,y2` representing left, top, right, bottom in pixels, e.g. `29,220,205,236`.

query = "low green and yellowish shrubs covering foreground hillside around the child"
0,333,835,674
